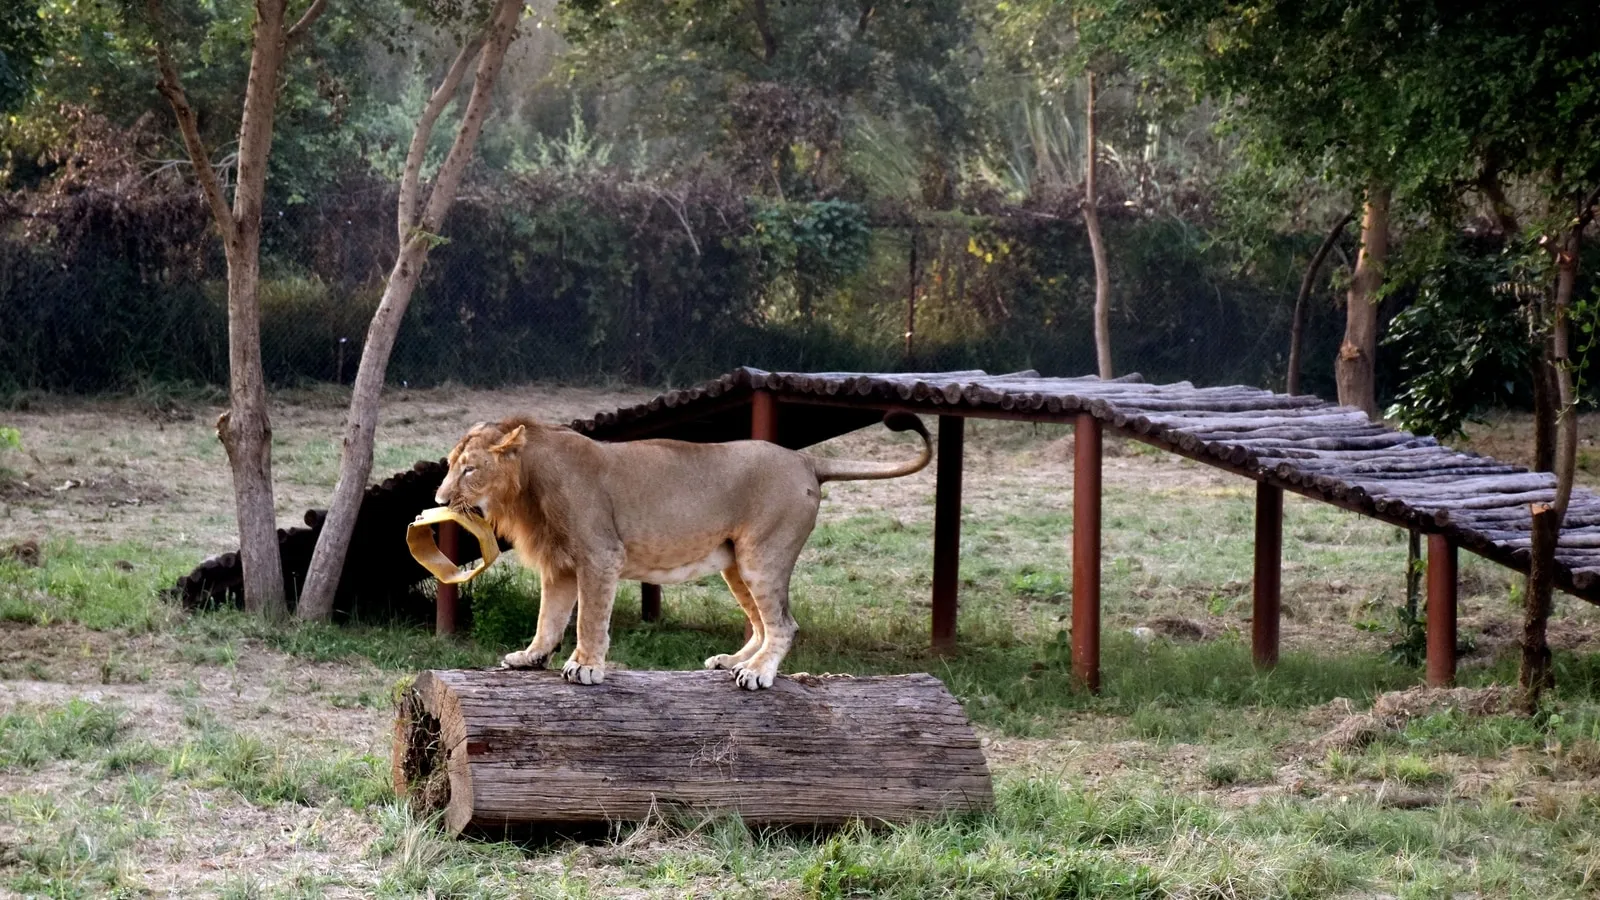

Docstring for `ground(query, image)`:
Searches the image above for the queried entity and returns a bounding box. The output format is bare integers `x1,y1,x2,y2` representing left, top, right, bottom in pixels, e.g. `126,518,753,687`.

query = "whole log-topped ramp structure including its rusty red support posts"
573,368,1600,685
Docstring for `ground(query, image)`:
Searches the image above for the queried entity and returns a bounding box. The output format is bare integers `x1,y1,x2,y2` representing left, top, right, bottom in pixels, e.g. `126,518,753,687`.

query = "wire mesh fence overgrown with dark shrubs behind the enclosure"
0,180,1363,392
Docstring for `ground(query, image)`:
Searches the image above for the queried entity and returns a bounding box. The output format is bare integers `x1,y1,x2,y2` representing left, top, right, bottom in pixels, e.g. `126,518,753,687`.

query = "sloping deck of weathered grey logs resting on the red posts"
573,368,1600,604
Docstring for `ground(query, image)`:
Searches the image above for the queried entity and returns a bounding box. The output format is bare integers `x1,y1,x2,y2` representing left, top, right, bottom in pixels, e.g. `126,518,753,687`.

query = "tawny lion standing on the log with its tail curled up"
435,413,933,690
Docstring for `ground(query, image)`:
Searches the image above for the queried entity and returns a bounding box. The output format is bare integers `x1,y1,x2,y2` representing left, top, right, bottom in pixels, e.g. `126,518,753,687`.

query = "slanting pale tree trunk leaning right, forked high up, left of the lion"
296,0,523,620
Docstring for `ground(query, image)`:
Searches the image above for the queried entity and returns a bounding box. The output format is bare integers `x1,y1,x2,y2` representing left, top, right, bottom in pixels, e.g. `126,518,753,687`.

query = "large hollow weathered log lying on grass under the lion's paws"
392,669,994,833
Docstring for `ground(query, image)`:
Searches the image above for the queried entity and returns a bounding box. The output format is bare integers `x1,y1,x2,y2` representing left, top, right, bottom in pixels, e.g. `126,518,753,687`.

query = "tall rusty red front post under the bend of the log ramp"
1072,413,1101,693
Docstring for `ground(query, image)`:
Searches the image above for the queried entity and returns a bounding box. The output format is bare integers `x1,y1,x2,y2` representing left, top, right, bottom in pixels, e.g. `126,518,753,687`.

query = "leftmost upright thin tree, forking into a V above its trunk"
146,0,328,618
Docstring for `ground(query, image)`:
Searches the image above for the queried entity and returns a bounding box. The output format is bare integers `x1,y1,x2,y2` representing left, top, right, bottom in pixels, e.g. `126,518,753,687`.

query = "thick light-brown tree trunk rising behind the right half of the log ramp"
1333,181,1390,418
